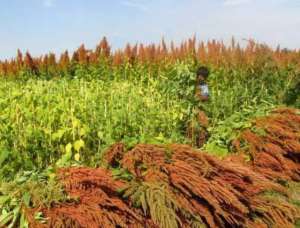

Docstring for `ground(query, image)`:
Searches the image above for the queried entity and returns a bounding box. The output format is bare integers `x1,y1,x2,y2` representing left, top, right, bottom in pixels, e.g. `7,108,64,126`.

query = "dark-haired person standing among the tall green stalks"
195,67,210,147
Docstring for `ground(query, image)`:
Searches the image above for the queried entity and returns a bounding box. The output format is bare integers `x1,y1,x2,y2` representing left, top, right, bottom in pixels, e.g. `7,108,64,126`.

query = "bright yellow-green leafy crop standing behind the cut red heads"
0,75,187,178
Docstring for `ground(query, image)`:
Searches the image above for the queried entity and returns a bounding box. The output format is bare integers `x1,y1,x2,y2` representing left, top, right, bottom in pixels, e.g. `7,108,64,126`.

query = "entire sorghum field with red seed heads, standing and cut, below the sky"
0,38,300,228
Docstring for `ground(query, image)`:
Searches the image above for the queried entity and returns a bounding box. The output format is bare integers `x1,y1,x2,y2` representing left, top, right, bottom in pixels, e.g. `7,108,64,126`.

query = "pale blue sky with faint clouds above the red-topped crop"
0,0,300,59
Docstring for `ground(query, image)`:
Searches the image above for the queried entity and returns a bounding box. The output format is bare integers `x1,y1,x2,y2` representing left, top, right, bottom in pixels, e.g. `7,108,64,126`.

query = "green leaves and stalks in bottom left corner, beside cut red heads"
0,169,68,228
